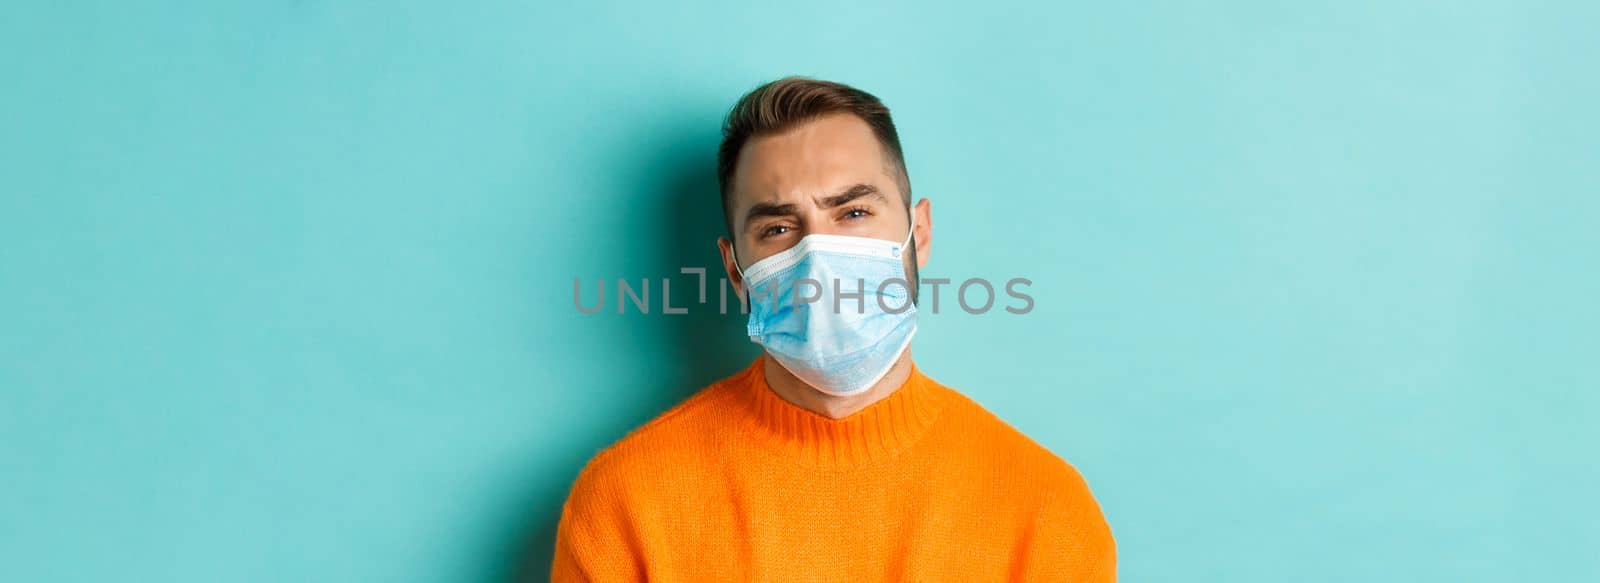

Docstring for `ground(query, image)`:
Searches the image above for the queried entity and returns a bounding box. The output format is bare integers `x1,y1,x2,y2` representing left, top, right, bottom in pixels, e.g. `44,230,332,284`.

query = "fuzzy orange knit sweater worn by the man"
552,359,1117,581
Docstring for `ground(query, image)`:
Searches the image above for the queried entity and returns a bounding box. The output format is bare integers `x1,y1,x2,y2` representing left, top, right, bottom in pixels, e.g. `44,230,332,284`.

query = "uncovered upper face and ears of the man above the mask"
718,114,931,296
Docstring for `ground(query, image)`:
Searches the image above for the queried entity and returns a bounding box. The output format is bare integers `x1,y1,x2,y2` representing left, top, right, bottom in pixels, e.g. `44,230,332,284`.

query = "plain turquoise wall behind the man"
0,2,1600,581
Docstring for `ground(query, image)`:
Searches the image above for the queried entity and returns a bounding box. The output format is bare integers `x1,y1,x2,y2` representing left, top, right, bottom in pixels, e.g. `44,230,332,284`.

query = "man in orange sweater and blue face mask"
552,77,1115,581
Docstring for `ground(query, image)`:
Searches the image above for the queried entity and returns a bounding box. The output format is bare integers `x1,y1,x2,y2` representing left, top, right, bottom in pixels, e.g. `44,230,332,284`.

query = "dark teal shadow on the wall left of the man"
506,120,758,581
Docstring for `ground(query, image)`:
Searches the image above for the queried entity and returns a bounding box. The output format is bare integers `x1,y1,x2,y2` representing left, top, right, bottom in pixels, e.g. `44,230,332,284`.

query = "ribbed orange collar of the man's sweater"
734,356,944,466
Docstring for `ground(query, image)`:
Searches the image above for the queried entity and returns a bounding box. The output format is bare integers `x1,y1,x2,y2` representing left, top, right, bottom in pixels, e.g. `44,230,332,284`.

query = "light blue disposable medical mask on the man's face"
734,227,917,396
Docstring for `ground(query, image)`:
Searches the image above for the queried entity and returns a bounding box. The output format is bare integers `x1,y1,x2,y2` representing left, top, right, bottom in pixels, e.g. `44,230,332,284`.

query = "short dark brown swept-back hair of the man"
717,77,910,240
